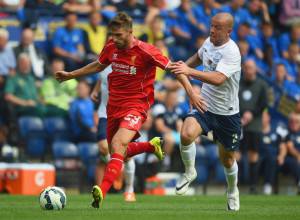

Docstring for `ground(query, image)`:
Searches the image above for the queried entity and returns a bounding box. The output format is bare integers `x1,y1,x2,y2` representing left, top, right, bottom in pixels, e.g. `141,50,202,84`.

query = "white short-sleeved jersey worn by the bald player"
198,38,241,115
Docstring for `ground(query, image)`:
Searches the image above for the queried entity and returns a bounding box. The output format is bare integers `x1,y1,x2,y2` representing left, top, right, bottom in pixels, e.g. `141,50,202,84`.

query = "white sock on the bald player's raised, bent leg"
180,142,196,174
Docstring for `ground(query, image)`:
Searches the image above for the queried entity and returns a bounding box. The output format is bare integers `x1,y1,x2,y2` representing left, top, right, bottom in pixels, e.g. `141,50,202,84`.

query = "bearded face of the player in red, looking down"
110,28,132,49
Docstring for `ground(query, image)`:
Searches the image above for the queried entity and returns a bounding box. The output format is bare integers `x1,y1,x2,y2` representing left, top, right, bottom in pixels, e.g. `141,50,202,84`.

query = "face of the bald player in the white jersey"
210,18,230,46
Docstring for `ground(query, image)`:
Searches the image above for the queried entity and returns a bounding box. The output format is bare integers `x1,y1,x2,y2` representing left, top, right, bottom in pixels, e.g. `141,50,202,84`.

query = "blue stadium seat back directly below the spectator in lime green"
44,117,70,141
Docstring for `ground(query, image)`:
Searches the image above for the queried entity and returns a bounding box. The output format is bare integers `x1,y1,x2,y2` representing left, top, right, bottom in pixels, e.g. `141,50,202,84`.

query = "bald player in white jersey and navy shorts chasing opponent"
171,13,241,211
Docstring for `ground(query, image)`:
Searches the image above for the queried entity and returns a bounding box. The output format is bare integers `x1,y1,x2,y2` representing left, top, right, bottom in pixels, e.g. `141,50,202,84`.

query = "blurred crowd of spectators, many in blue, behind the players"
0,0,300,194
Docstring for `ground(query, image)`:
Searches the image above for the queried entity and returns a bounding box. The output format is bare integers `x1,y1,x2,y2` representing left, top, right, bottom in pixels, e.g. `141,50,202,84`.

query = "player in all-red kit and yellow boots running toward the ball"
55,12,170,208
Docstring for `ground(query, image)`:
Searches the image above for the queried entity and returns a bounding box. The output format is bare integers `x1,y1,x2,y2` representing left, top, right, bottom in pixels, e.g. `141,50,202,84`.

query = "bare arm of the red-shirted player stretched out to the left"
55,61,106,82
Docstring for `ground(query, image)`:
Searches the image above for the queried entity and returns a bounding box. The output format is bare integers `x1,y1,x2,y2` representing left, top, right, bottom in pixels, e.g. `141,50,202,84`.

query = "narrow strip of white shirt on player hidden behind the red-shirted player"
98,65,112,118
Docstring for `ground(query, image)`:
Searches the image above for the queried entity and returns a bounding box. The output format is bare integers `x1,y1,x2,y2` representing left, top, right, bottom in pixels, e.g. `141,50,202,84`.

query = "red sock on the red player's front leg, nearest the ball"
100,153,124,197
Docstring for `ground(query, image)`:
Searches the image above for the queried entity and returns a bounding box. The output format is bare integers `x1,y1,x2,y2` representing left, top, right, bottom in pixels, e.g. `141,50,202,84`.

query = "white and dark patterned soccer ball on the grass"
39,186,67,210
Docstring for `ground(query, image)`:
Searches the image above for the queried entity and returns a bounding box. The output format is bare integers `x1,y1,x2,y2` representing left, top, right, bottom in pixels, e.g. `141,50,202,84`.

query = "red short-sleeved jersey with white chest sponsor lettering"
98,39,169,111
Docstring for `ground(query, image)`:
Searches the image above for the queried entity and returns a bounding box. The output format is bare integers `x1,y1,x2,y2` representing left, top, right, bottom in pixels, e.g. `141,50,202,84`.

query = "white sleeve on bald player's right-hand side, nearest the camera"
216,46,241,78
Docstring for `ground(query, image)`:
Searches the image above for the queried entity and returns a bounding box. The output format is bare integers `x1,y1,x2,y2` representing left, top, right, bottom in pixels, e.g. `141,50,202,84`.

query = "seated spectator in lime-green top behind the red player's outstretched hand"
40,59,77,117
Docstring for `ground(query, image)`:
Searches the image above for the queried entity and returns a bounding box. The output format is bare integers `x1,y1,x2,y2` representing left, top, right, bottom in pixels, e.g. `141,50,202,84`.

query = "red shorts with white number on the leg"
106,106,147,144
